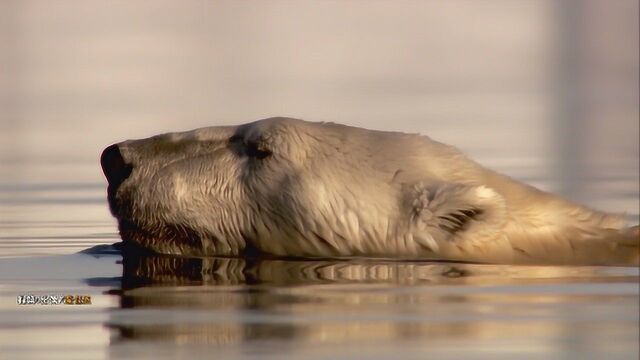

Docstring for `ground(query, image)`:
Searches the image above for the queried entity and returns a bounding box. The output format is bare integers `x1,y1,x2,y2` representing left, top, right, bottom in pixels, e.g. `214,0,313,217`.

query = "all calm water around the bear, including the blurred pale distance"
0,0,640,360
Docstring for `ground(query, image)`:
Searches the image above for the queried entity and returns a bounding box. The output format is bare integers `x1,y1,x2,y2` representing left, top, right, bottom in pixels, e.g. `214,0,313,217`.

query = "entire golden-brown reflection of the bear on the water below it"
109,252,638,358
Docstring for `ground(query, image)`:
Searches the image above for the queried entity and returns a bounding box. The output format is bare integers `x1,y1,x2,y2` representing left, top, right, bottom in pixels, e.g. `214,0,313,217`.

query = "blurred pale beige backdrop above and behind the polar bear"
0,0,639,214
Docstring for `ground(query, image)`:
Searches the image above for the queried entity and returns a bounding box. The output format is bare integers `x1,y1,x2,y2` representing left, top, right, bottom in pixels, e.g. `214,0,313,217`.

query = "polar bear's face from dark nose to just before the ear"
101,118,444,256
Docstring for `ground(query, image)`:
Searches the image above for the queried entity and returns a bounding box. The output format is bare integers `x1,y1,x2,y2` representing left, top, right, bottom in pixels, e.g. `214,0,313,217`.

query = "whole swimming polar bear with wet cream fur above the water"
101,117,640,264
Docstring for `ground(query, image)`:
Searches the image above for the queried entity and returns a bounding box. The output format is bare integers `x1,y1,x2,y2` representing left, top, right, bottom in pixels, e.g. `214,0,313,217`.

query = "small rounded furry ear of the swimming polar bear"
409,183,506,252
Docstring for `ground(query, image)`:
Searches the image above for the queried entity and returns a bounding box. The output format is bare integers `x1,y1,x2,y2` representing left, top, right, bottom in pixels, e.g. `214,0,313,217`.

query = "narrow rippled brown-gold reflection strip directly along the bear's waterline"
123,255,636,289
